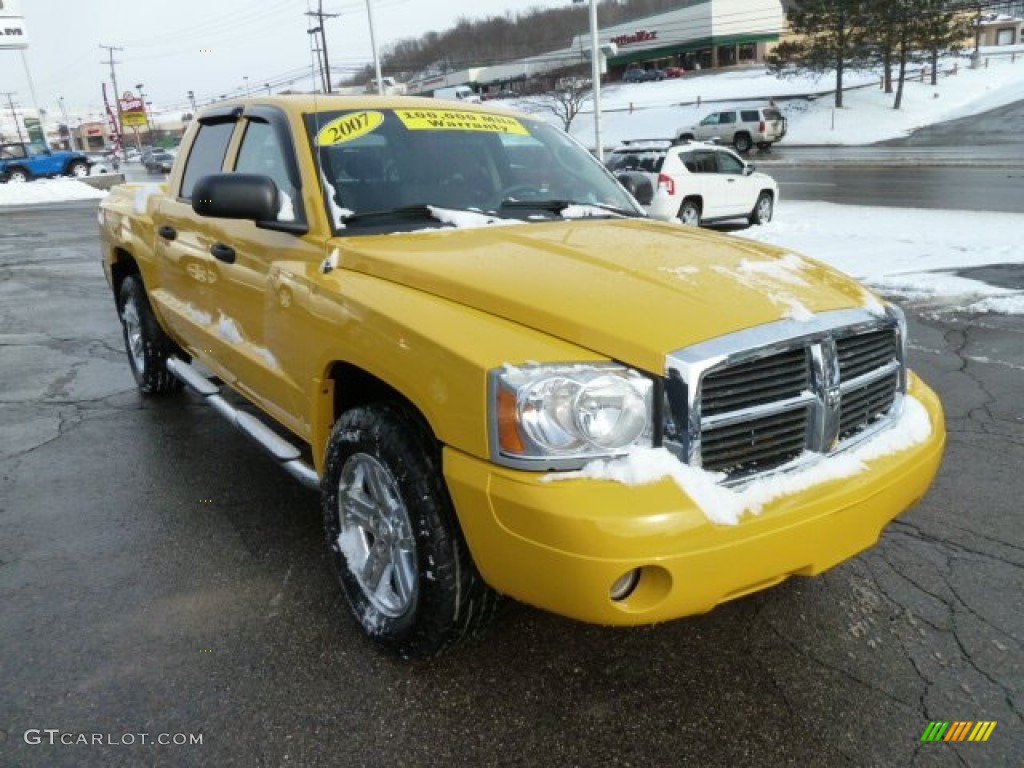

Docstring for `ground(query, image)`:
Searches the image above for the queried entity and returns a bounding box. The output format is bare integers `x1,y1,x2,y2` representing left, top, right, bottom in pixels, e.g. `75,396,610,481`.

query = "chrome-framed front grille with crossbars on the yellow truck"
665,310,906,478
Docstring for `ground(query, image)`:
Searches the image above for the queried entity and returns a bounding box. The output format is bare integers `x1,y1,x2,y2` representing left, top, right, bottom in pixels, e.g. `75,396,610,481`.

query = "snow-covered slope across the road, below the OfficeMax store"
524,53,1024,146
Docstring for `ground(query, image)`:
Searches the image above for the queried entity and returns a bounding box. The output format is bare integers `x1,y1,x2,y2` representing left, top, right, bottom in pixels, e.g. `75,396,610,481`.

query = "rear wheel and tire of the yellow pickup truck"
118,274,187,395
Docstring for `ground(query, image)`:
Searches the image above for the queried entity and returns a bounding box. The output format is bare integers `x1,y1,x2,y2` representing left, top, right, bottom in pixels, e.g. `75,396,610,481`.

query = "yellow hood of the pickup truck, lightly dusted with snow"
329,219,878,372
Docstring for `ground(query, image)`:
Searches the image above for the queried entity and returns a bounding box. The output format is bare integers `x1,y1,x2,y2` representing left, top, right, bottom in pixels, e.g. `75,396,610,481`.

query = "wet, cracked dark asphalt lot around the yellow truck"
0,204,1024,766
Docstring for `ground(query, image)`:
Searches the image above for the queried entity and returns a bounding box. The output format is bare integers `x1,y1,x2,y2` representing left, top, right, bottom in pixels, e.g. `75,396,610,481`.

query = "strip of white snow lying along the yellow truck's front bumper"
545,396,932,525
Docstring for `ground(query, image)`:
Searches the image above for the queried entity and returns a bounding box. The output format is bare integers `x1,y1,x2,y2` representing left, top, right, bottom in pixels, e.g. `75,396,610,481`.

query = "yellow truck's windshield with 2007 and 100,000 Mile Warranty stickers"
306,109,643,229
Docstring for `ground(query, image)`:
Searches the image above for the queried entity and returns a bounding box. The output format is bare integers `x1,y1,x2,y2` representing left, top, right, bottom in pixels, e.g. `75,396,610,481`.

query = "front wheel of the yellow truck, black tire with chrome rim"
321,403,498,658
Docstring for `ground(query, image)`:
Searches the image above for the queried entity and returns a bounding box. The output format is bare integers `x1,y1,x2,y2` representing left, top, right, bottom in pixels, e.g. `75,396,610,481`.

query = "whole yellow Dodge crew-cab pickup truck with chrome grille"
98,96,945,657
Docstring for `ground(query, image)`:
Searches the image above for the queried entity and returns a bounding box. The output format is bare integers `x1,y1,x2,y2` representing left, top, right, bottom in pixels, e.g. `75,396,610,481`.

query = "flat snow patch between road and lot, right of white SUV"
736,200,1024,314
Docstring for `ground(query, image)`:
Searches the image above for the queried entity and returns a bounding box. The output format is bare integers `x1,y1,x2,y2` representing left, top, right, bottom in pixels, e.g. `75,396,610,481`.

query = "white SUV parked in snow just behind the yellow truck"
605,141,778,226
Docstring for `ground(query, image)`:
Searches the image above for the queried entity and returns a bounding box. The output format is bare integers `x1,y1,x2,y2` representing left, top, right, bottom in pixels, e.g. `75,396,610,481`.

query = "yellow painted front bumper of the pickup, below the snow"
444,379,945,625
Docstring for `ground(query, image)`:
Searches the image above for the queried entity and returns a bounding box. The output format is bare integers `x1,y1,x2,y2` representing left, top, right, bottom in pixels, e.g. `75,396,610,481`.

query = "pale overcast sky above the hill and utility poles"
0,0,571,117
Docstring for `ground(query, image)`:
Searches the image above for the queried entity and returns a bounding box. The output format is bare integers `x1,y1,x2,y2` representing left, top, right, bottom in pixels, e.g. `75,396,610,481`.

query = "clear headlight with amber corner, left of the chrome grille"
490,364,654,469
